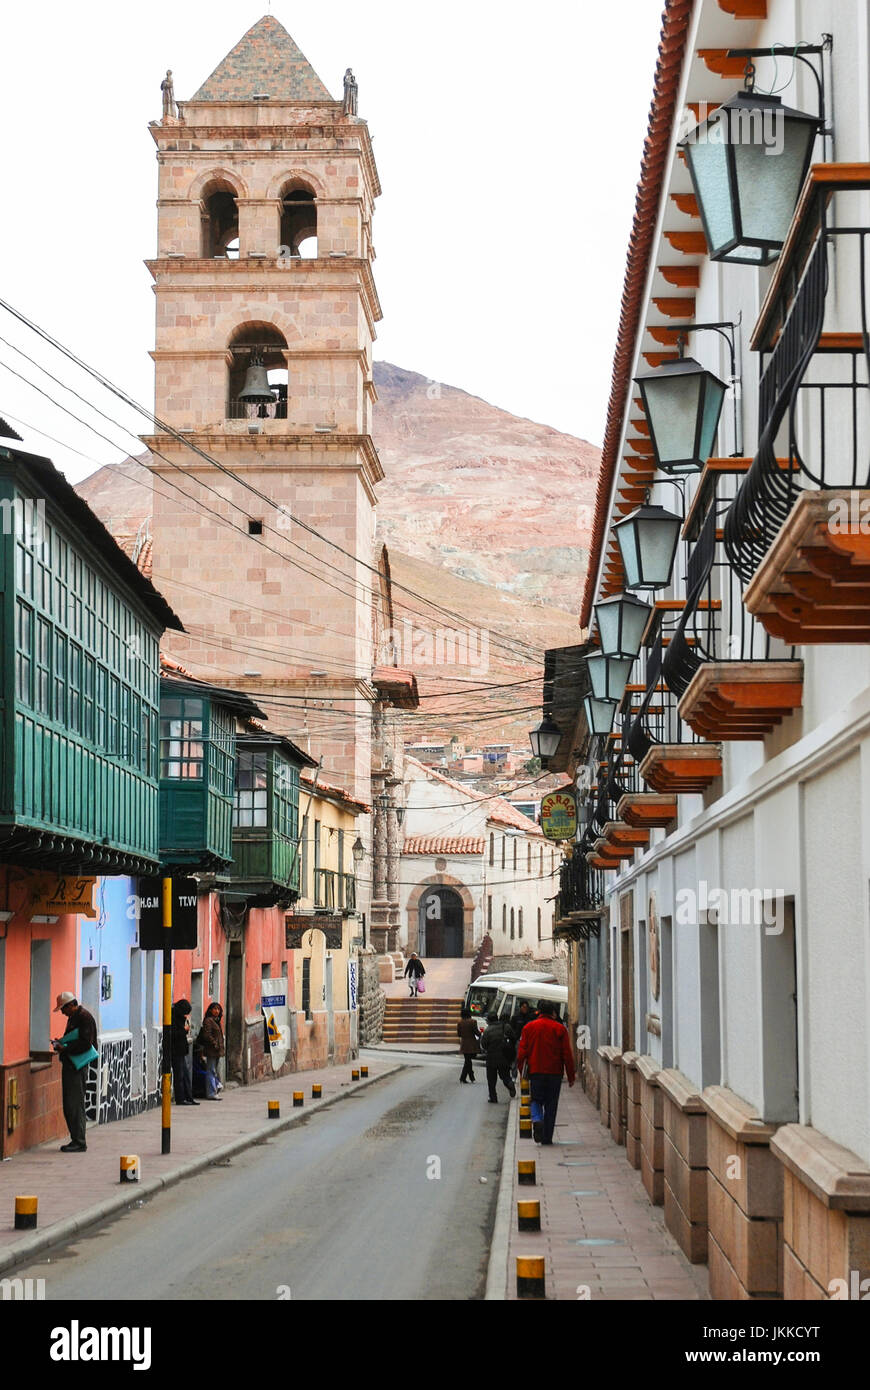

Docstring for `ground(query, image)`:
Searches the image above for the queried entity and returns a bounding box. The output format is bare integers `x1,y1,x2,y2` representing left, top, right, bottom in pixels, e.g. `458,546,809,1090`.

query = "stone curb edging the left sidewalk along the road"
0,1063,404,1272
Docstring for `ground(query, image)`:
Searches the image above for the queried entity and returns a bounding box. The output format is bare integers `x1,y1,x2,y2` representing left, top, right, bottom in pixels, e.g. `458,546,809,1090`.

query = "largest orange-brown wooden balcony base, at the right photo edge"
744,488,870,646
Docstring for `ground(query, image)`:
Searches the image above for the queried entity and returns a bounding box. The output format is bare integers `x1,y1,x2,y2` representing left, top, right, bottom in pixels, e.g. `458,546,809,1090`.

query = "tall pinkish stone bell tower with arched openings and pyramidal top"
145,15,382,795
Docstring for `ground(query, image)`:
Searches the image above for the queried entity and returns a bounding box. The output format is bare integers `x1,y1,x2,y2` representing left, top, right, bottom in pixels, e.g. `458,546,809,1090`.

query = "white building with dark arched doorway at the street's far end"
399,756,561,960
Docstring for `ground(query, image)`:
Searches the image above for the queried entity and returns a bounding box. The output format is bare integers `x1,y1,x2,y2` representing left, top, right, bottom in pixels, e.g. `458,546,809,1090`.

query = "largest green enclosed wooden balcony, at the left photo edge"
0,428,182,874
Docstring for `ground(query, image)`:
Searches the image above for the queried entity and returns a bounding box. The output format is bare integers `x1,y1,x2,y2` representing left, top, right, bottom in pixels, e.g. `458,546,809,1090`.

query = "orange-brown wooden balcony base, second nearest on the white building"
678,662,803,742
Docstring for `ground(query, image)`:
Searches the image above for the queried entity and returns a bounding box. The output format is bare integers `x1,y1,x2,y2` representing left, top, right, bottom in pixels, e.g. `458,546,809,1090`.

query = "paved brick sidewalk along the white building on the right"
507,1081,709,1301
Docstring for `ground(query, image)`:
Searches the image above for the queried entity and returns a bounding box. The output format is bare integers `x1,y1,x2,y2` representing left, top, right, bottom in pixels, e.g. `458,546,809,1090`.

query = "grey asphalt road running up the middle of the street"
15,1058,507,1301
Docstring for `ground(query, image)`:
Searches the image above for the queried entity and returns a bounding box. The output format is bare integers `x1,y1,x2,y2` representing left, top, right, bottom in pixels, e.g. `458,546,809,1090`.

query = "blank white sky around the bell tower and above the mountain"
0,0,662,481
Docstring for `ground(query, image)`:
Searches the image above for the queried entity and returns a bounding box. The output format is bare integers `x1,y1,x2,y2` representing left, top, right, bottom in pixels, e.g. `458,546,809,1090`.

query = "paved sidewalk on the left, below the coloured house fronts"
0,1055,399,1269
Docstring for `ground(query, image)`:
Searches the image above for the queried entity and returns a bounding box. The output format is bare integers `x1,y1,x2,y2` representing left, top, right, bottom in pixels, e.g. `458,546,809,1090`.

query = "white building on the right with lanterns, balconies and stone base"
548,0,870,1300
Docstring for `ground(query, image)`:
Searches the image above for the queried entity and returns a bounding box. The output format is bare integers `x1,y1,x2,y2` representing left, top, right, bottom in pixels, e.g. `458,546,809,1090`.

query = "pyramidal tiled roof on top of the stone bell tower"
192,14,332,101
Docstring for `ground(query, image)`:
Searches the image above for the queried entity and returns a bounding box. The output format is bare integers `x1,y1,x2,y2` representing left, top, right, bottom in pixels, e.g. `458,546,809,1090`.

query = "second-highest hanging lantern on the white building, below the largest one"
634,357,728,474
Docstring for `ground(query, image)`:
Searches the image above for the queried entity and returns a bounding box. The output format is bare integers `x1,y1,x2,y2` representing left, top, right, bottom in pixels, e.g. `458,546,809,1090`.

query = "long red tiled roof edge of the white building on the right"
580,0,695,627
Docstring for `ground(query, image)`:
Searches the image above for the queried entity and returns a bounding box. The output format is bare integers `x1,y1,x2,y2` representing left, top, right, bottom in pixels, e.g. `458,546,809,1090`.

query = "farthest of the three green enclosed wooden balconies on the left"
229,734,317,908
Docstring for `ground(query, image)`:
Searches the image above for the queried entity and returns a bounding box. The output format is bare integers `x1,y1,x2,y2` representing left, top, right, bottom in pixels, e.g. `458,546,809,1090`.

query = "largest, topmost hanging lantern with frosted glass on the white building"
678,87,821,265
